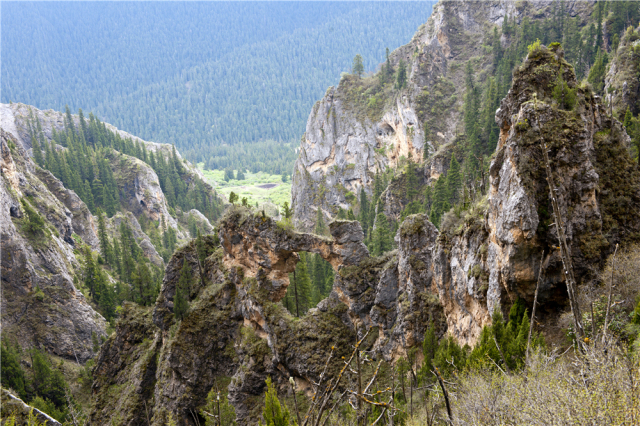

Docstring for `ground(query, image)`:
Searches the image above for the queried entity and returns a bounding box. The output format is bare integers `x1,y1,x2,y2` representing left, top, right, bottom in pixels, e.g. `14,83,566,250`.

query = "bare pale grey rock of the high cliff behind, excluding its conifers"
292,1,593,230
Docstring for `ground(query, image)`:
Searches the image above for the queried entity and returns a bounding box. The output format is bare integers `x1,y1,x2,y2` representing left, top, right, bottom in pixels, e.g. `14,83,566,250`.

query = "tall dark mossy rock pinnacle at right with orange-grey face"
434,42,640,343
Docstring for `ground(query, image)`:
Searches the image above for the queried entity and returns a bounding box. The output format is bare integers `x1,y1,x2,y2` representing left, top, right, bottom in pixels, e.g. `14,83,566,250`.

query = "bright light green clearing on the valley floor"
198,163,291,206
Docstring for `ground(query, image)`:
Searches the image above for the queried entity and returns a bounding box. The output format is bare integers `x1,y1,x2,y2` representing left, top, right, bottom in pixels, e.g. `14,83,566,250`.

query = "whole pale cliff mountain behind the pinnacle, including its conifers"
292,1,616,230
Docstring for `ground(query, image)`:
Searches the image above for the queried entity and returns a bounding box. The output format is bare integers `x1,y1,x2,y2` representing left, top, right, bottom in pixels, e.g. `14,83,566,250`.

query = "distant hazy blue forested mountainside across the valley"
1,2,435,174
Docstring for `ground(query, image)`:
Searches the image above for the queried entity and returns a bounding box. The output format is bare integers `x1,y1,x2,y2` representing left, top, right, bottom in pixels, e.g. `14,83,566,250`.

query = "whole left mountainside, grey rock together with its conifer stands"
0,104,223,420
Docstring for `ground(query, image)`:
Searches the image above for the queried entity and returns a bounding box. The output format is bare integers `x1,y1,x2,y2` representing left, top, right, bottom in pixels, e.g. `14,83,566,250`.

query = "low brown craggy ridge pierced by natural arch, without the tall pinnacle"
92,207,446,425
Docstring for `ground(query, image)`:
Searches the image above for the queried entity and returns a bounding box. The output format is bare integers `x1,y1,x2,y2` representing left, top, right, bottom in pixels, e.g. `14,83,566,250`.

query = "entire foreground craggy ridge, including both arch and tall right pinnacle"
91,43,640,425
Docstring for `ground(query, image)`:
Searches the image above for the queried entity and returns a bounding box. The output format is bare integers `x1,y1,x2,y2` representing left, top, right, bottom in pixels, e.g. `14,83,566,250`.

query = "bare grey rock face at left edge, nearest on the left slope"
0,125,106,362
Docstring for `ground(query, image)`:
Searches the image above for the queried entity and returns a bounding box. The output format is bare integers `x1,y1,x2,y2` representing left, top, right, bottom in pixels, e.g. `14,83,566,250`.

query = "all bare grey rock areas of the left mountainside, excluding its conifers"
0,104,215,362
